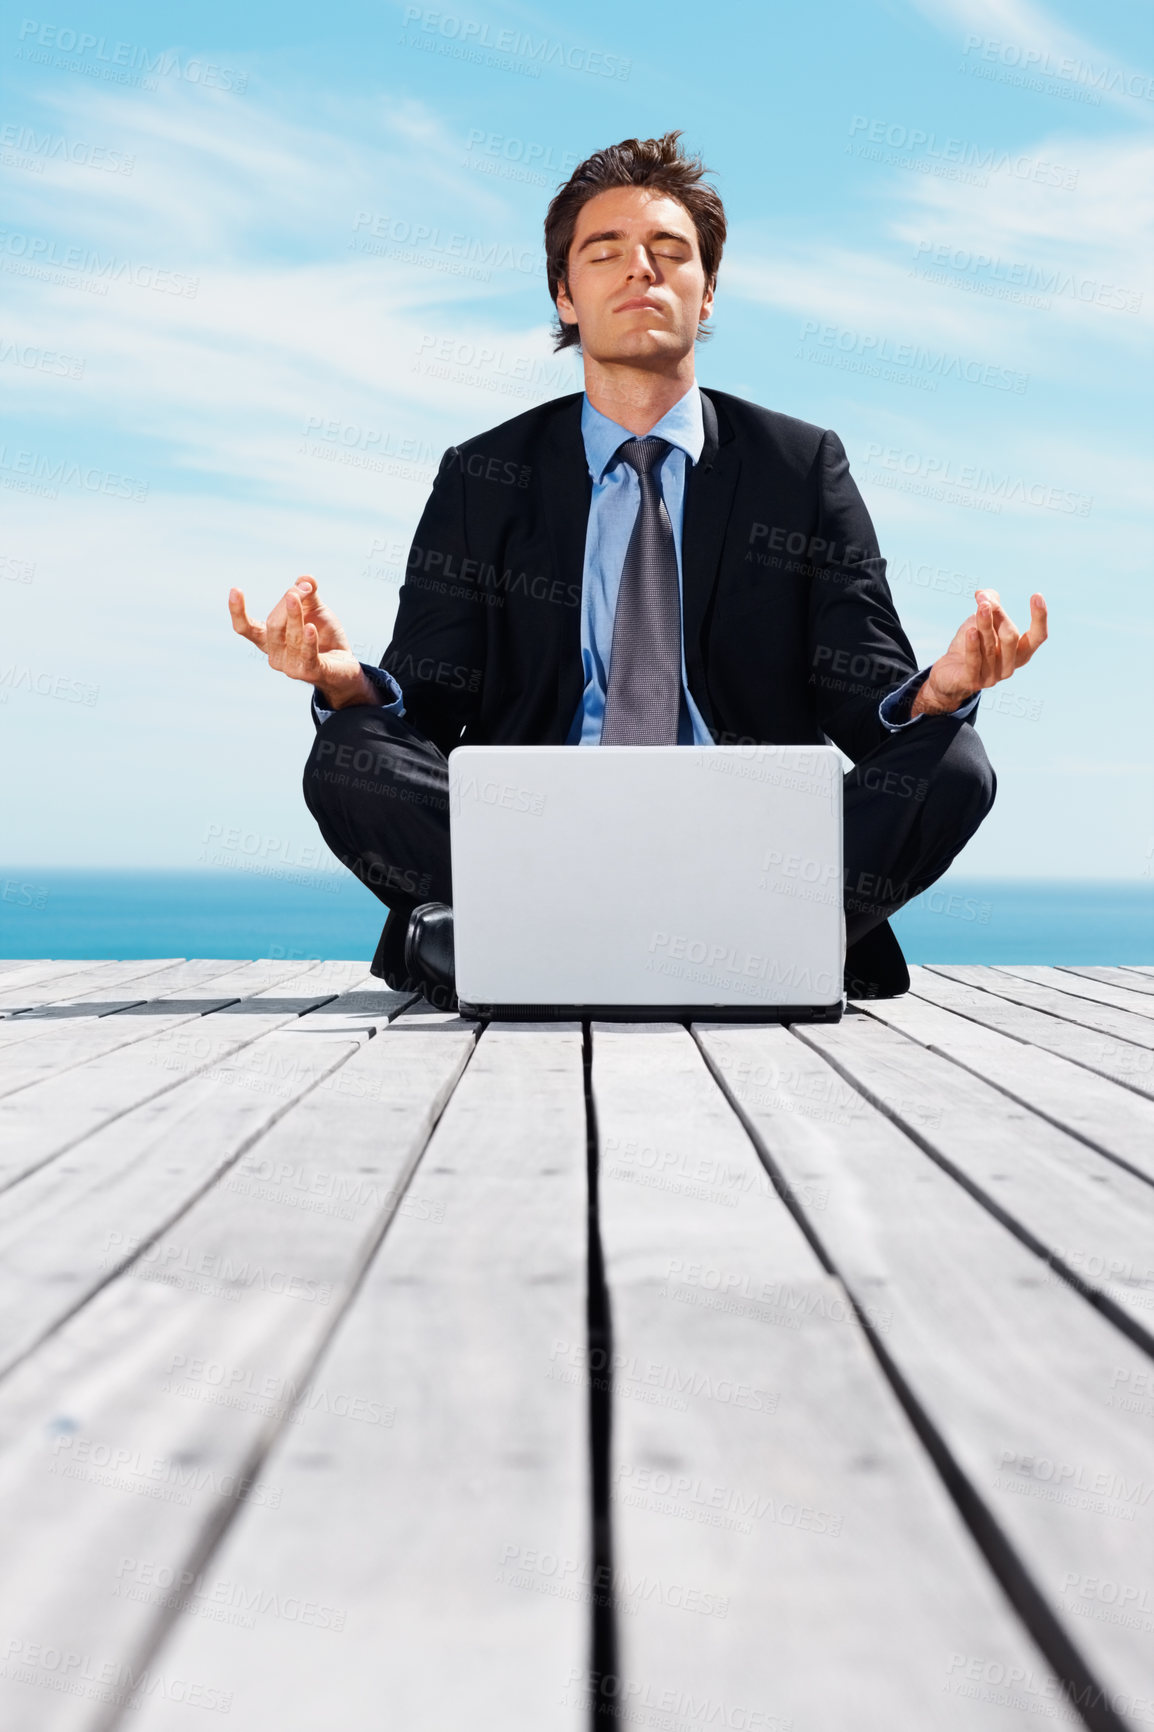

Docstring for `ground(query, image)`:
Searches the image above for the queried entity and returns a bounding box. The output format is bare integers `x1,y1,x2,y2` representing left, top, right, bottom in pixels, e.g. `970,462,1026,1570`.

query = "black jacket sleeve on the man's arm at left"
381,445,487,755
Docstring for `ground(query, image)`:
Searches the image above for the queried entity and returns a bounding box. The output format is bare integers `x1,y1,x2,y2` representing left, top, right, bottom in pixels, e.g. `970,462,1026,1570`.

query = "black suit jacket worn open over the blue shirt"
381,390,917,762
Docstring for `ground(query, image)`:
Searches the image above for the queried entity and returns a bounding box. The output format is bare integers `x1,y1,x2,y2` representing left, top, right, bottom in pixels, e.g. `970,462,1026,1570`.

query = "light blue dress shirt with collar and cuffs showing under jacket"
312,385,977,746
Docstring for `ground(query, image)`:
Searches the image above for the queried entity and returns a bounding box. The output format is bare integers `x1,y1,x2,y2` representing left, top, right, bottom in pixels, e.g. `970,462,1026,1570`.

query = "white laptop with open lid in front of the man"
449,745,846,1022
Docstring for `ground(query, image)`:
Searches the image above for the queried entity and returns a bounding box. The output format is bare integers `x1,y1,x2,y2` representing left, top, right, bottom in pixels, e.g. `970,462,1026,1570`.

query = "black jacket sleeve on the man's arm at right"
809,433,918,762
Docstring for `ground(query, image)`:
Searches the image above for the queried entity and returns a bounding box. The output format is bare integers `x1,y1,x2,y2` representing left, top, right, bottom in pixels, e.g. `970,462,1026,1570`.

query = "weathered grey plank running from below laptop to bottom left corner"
0,1018,473,1732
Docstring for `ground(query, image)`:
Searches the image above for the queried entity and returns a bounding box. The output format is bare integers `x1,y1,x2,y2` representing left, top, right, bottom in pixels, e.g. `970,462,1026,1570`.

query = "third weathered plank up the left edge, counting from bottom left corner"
0,963,364,1185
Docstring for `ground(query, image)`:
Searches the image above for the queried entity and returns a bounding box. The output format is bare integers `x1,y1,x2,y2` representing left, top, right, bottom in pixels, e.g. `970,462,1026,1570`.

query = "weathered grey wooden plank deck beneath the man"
0,960,1154,1732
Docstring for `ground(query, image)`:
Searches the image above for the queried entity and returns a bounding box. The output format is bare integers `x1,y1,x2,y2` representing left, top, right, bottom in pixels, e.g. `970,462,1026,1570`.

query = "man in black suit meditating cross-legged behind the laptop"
229,133,1047,1003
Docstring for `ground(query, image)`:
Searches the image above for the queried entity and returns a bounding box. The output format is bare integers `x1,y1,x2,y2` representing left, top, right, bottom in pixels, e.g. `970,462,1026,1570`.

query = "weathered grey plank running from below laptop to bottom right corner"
698,1027,1154,1727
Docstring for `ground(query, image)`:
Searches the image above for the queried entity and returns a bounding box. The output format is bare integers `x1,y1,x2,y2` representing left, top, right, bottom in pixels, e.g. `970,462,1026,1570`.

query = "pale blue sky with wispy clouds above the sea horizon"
0,0,1154,880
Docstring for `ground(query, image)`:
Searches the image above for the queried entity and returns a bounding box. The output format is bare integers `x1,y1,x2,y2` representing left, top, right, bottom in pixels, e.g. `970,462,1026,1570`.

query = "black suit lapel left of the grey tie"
541,393,593,745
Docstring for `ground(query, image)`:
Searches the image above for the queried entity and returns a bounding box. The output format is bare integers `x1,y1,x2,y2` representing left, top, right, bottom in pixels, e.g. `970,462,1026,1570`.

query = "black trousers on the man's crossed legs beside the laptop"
305,705,996,996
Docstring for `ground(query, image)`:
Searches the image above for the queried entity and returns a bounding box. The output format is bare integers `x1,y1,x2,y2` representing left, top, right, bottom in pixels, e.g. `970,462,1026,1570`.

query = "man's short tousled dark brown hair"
546,130,726,350
